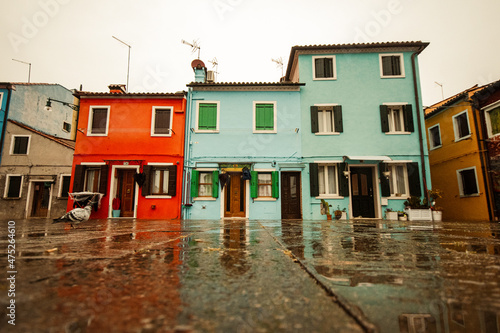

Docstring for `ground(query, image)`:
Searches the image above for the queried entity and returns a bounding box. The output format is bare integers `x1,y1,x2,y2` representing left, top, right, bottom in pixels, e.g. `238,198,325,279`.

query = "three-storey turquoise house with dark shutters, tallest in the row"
285,42,430,220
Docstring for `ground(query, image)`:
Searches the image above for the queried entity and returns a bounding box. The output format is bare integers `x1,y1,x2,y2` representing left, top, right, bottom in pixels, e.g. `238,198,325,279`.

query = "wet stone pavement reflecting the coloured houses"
0,219,500,332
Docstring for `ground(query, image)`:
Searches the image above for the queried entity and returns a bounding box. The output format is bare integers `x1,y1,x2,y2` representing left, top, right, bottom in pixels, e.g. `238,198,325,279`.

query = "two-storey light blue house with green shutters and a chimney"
183,60,305,219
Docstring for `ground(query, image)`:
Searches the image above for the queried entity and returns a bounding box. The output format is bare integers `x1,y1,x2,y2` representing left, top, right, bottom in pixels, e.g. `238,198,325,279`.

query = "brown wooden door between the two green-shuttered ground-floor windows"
224,172,246,217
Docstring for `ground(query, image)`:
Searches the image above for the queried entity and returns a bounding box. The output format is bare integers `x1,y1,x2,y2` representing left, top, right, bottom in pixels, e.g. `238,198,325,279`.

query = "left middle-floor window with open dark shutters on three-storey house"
311,105,344,134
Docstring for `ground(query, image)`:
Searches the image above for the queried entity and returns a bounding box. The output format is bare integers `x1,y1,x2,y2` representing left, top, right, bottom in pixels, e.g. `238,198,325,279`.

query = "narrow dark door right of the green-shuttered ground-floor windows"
281,172,302,219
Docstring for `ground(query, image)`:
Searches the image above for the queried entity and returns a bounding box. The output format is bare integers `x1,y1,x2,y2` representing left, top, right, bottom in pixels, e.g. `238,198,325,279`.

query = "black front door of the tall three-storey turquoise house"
351,167,375,218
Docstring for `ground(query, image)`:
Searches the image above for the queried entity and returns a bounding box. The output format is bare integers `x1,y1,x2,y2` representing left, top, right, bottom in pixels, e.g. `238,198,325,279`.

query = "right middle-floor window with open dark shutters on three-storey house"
380,104,414,134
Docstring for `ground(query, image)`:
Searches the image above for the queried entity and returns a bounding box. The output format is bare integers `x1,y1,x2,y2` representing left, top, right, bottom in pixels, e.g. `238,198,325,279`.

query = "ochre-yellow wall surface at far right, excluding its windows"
425,102,489,221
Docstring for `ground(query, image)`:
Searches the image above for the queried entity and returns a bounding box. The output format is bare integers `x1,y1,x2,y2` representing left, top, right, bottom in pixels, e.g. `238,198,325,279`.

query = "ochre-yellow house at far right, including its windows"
425,85,494,221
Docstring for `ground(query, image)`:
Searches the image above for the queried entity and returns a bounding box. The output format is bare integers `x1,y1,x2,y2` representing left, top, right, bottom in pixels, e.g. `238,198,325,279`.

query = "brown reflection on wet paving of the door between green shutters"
220,220,250,275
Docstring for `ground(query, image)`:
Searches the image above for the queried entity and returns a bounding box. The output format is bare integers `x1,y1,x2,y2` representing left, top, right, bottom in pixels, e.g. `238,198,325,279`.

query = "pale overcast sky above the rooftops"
0,0,500,105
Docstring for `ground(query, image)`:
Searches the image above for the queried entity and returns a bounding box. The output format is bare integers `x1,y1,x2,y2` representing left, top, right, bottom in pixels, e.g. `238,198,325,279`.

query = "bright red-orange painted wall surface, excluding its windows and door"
68,95,186,219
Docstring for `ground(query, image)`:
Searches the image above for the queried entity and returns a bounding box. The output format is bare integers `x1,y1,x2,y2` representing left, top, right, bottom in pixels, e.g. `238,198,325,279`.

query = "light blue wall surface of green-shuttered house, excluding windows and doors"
184,88,302,219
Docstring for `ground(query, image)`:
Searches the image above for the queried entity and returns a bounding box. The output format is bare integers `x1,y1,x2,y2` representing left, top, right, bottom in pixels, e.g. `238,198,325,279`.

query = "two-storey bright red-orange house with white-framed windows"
68,85,186,219
